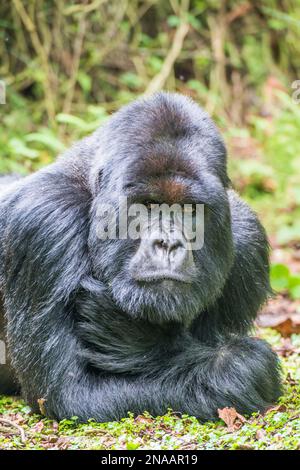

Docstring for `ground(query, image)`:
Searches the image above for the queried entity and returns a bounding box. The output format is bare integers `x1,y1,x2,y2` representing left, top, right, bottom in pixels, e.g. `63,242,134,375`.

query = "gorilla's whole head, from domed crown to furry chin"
89,93,233,323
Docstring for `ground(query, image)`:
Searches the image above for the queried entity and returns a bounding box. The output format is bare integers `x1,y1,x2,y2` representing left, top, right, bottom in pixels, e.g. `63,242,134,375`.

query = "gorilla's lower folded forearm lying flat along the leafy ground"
26,324,279,421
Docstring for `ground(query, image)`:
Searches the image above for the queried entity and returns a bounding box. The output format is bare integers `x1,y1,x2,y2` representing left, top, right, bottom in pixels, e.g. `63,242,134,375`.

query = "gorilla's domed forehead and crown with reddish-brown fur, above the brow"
95,93,227,192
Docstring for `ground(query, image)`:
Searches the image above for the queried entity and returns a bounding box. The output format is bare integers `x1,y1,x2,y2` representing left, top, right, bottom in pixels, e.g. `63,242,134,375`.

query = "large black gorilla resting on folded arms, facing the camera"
0,93,281,421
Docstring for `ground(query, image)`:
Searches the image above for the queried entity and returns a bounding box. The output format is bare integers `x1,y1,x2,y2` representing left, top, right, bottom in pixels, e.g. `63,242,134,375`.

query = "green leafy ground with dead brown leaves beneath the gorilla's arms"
0,329,300,450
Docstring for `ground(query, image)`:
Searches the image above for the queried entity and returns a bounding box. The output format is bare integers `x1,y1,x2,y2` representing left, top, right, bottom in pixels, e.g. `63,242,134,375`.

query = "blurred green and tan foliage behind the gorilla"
0,0,300,260
